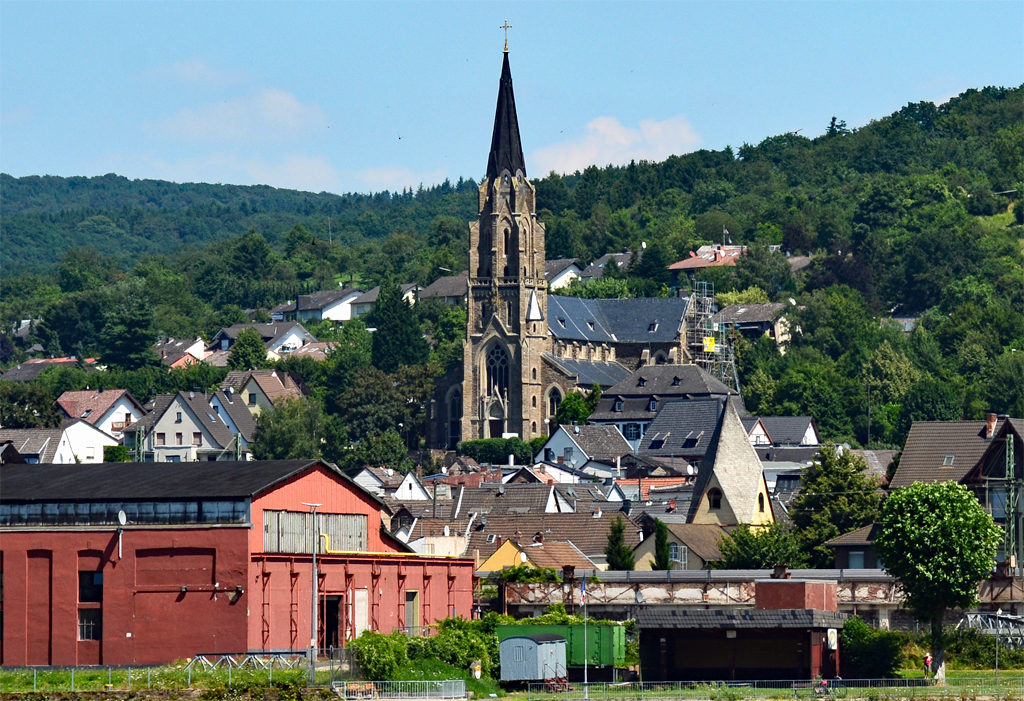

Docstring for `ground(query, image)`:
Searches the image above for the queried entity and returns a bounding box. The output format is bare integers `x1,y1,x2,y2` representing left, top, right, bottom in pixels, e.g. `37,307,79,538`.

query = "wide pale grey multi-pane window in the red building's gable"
263,511,369,553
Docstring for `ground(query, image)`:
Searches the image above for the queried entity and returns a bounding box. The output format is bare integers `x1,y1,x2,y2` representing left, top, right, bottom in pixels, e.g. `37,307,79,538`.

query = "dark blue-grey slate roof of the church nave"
548,294,689,345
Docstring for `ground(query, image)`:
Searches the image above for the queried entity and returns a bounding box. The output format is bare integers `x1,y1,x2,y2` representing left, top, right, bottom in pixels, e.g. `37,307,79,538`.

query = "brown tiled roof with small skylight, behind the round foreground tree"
889,421,1001,488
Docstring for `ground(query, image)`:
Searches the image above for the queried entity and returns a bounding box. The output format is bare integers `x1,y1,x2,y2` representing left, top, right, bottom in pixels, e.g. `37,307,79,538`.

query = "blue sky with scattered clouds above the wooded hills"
0,0,1024,192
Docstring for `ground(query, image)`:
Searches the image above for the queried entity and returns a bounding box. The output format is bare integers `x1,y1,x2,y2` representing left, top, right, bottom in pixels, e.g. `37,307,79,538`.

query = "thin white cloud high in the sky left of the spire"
152,88,327,142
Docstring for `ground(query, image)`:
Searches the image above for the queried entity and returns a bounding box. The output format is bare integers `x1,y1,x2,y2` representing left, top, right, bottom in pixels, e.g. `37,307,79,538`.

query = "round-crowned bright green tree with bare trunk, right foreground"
874,482,1002,680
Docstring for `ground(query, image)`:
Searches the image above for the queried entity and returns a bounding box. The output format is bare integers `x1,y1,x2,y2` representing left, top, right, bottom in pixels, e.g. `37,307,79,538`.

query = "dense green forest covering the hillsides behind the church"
0,87,1024,454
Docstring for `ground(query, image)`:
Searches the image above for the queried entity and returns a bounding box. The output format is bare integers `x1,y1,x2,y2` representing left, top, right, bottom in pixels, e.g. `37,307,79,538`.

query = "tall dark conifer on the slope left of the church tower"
371,279,430,373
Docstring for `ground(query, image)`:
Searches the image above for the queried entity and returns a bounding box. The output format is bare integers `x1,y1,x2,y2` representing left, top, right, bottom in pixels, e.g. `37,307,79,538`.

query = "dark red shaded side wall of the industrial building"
0,527,249,665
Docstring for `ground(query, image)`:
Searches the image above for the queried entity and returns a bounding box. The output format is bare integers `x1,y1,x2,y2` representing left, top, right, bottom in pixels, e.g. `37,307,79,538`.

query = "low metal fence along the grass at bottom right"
527,673,1024,701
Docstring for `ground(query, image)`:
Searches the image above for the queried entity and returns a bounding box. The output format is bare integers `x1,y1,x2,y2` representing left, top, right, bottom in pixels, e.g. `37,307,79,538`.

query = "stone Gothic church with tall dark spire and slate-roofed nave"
427,46,690,449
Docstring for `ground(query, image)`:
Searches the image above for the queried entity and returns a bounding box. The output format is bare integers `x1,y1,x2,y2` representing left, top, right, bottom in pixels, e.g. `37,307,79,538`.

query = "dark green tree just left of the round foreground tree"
790,443,882,567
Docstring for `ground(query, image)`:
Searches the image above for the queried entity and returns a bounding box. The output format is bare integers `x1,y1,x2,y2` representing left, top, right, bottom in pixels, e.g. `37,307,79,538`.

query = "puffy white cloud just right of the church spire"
531,116,700,173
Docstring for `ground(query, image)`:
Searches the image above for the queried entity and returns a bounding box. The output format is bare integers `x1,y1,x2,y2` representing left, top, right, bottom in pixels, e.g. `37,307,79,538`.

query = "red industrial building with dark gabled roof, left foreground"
0,461,474,665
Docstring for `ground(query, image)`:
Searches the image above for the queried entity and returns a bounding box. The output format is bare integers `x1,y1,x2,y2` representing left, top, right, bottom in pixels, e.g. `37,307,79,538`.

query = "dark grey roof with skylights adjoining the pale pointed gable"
638,397,729,462
